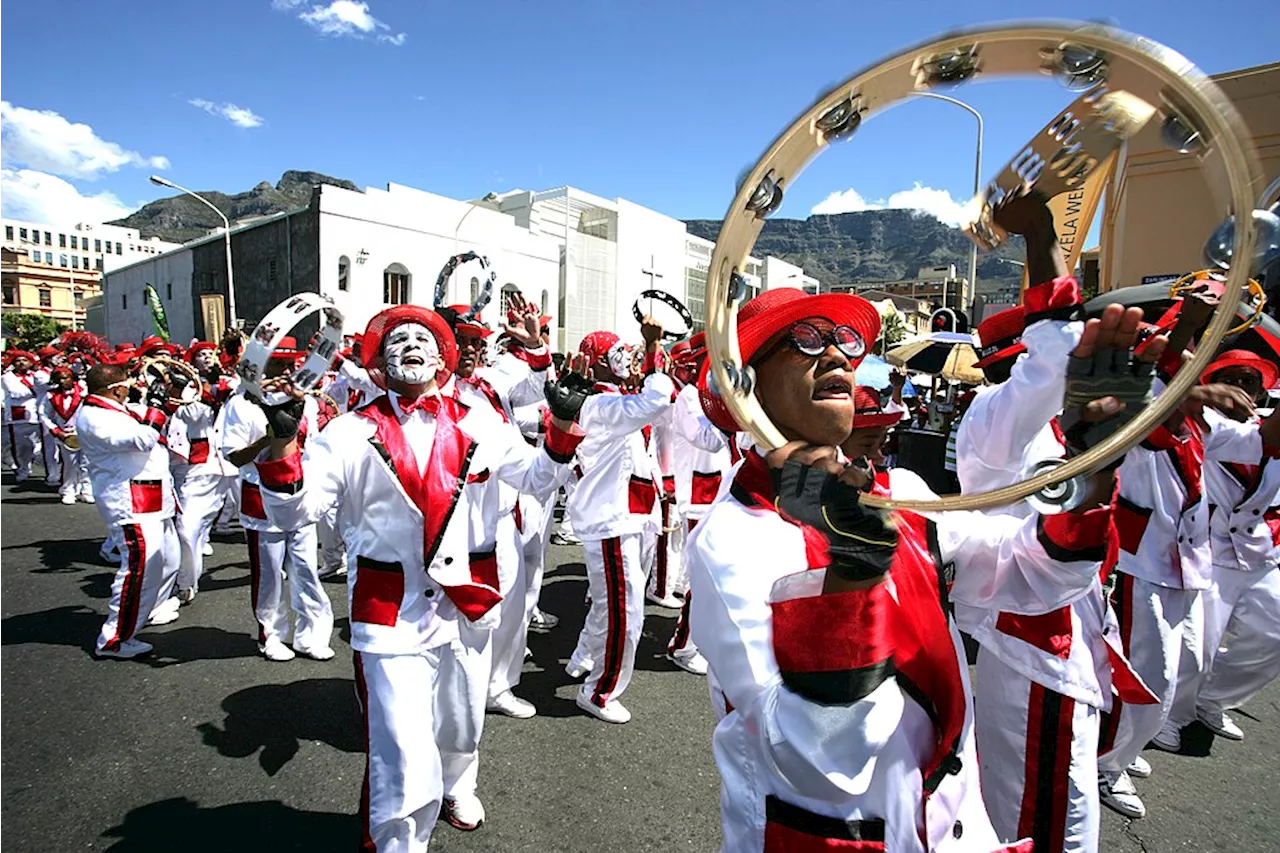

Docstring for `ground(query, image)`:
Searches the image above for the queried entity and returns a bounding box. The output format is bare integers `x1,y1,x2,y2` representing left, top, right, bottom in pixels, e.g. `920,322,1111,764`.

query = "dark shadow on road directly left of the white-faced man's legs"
196,679,365,773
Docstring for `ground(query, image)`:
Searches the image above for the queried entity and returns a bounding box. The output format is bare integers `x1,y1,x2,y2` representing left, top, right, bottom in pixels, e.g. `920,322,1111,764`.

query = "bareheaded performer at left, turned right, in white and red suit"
76,364,180,658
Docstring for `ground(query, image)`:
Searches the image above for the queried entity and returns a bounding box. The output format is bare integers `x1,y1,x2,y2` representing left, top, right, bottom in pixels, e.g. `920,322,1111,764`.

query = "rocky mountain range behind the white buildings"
110,169,1023,293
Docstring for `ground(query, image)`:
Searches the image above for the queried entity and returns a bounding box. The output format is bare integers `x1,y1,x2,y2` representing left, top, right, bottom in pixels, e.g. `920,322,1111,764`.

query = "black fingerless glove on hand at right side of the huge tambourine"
1059,348,1156,455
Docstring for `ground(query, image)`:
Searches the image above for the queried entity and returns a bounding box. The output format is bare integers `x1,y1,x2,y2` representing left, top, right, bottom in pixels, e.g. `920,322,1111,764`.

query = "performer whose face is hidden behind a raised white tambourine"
223,338,334,662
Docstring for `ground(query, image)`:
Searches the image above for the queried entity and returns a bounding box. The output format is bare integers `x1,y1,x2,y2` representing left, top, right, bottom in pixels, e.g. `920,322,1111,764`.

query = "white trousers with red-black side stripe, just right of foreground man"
974,649,1100,853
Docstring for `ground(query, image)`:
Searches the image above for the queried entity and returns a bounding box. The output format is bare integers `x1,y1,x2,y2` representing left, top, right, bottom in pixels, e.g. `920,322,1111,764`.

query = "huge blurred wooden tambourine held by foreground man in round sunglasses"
707,23,1262,511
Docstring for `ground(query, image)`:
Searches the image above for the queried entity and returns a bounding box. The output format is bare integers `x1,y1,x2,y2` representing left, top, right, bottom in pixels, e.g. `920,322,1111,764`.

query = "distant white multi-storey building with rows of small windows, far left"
0,216,179,273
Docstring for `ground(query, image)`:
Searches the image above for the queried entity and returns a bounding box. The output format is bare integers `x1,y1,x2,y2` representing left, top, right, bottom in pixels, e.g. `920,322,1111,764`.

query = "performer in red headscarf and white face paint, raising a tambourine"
566,320,675,724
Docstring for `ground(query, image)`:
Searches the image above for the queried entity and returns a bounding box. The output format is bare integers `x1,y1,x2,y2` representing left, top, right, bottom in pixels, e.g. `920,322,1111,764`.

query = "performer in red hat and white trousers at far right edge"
1167,350,1280,748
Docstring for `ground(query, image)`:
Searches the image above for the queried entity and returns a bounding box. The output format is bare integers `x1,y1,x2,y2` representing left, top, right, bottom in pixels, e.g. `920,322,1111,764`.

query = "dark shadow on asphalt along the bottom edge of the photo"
102,797,360,853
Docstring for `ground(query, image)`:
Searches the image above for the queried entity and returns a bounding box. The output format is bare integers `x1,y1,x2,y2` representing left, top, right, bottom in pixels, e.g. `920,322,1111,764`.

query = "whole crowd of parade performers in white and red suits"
3,196,1280,853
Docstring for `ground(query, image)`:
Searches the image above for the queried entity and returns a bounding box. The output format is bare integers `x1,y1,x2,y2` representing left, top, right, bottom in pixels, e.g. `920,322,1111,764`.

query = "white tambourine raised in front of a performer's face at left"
236,292,343,406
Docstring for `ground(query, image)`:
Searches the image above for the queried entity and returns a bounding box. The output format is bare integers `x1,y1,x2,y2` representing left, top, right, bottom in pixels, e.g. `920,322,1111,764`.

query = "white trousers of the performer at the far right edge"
1199,566,1280,711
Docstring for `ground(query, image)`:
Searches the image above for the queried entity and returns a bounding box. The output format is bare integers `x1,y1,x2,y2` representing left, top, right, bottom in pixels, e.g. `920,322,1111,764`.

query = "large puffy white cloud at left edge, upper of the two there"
0,101,169,179
